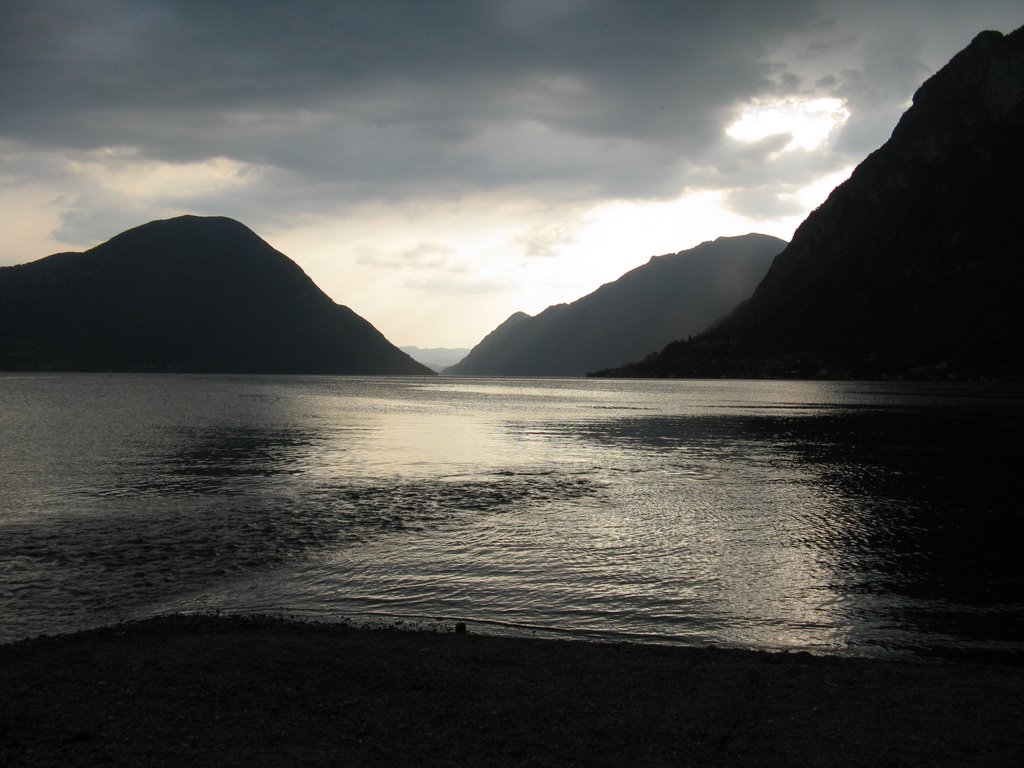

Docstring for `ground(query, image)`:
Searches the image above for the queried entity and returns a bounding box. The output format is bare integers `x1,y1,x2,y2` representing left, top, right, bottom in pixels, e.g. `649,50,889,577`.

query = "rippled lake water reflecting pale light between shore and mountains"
0,375,1024,657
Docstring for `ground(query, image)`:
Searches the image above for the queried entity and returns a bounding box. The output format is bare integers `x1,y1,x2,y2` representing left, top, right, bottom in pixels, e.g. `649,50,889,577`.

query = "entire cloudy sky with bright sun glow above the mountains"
0,0,1024,347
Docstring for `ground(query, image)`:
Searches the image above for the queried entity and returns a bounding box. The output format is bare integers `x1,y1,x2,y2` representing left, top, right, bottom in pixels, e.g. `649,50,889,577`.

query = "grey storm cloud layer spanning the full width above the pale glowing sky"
0,0,1020,243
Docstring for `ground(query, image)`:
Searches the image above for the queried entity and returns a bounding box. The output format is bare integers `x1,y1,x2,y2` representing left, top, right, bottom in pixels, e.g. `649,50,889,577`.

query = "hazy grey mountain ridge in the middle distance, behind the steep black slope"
443,234,785,376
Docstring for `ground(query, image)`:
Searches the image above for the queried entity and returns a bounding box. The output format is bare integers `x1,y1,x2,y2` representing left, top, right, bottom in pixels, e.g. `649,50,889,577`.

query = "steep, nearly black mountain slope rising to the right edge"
601,28,1024,379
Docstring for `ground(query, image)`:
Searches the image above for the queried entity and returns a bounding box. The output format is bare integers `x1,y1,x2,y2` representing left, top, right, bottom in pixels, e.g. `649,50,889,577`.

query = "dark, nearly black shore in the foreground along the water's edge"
0,616,1024,768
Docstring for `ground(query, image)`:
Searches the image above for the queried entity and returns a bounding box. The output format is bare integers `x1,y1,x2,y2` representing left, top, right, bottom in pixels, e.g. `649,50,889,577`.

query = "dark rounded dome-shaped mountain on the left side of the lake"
0,216,433,374
